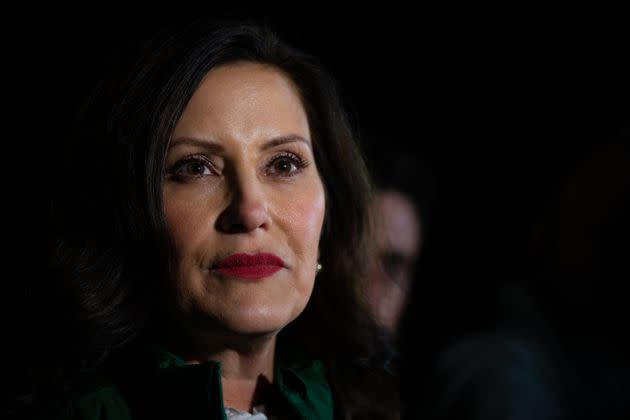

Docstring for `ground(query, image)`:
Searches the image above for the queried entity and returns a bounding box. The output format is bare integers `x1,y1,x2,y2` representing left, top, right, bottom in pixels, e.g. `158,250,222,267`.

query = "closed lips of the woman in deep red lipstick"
212,253,286,280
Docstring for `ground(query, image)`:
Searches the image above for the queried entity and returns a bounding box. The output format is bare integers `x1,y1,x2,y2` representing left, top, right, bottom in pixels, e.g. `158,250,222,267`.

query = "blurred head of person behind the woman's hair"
367,142,434,337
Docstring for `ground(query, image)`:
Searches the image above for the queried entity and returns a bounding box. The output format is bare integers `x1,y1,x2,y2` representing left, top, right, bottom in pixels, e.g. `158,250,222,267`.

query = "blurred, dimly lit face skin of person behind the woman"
368,190,421,334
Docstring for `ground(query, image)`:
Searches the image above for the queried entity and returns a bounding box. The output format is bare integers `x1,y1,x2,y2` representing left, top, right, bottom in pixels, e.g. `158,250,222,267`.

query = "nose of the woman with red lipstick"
217,173,271,233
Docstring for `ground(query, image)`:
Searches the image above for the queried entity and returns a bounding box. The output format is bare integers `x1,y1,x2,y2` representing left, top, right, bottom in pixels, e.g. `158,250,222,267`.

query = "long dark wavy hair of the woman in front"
23,20,398,418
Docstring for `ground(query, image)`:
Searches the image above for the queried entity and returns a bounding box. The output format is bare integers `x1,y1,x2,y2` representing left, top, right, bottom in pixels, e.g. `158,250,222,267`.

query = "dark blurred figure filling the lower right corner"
414,131,630,420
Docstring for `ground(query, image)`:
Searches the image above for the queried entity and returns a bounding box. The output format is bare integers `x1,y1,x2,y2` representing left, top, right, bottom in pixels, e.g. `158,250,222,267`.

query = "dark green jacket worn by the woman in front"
32,348,333,420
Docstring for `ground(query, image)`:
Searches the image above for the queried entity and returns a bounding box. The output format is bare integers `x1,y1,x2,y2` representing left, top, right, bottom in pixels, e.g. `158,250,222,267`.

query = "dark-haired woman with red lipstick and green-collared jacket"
18,17,398,420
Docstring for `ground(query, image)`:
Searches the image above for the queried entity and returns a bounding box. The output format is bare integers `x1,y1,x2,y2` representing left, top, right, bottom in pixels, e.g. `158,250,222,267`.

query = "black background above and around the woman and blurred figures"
5,0,630,412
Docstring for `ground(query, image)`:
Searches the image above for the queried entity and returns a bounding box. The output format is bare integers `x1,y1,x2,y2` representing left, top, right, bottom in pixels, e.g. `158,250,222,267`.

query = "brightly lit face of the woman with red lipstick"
164,62,325,334
